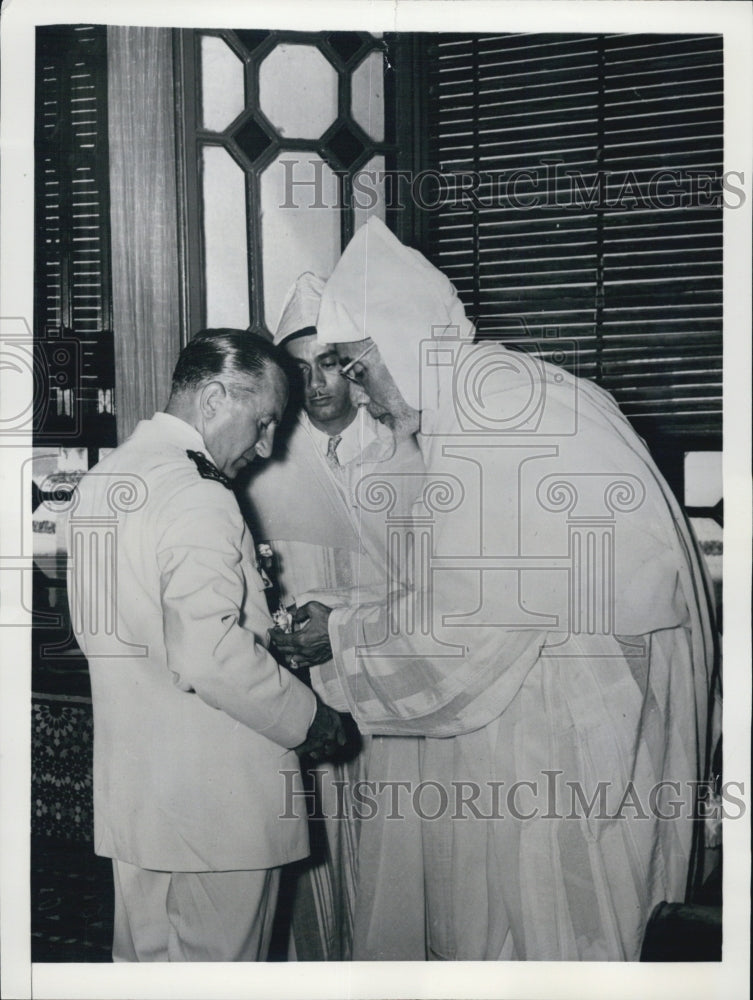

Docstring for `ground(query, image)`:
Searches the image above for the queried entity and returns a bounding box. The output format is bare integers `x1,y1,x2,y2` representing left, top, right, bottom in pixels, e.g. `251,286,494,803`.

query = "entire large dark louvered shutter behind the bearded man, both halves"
423,35,722,450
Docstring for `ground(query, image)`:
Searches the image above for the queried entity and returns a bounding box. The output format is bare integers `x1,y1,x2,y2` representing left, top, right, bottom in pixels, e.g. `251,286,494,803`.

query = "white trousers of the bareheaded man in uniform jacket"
112,860,280,962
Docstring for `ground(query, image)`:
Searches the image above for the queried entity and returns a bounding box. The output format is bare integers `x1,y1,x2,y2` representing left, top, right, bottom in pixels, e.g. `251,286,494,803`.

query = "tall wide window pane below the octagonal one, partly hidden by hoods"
261,151,340,333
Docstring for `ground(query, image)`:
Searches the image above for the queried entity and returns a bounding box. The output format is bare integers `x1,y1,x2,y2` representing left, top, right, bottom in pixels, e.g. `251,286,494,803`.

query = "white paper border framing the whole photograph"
0,0,753,1000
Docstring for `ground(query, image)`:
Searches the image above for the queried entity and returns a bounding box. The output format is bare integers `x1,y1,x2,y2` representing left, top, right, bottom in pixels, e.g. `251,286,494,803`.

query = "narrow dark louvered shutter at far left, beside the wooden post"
34,25,114,445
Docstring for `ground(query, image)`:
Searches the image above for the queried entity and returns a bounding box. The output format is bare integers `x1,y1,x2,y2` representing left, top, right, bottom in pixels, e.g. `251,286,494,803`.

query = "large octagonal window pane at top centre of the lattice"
259,44,337,139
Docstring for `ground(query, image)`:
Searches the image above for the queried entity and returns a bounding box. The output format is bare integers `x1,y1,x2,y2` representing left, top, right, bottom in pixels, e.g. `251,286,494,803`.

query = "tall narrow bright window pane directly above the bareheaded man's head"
202,146,249,330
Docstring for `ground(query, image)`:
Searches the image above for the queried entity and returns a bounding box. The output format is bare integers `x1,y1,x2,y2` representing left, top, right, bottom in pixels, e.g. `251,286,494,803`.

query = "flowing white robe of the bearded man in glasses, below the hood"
312,350,714,960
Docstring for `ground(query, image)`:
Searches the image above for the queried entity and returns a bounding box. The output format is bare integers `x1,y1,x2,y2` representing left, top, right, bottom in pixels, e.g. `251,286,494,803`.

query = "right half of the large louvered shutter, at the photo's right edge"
600,36,723,437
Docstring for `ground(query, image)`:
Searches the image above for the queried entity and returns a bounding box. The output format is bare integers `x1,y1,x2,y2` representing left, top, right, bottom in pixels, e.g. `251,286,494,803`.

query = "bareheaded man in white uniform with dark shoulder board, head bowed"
69,330,344,961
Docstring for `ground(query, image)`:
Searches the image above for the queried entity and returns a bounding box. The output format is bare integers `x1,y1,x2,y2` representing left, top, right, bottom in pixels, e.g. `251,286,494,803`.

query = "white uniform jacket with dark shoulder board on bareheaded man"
69,413,315,871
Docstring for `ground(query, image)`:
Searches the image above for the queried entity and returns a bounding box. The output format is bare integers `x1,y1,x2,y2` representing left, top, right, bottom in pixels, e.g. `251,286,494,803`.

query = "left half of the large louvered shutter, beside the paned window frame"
427,36,598,374
